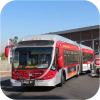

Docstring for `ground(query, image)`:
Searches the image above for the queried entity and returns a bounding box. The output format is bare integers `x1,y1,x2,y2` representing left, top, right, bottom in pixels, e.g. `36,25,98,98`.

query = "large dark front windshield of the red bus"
13,47,53,69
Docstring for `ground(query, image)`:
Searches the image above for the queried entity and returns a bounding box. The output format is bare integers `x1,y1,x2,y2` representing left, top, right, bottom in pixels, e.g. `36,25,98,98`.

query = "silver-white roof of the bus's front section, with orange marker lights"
20,34,79,46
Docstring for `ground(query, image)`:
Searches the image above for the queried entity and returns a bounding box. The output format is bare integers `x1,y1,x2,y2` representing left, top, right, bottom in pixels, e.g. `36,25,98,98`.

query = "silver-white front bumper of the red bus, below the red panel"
10,77,56,86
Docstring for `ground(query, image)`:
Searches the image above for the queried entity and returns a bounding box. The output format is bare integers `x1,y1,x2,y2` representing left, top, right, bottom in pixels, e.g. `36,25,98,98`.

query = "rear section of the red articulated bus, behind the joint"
80,45,94,73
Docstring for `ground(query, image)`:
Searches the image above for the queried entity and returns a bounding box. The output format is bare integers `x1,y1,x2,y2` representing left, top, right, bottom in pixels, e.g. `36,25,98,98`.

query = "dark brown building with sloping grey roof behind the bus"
47,25,100,52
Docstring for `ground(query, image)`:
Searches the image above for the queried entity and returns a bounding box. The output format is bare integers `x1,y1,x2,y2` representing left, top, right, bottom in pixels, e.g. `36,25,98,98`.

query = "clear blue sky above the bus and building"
0,0,100,53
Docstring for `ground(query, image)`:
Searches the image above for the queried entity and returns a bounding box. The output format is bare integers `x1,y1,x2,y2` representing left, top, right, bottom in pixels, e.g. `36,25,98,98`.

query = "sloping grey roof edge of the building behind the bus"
46,25,100,34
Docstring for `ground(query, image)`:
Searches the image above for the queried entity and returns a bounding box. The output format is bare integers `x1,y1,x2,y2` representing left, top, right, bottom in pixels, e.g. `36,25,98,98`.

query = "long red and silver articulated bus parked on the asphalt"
10,35,94,86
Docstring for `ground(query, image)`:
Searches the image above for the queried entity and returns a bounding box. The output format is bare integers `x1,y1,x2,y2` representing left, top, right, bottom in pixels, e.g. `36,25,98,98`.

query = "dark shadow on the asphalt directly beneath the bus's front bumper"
0,79,55,92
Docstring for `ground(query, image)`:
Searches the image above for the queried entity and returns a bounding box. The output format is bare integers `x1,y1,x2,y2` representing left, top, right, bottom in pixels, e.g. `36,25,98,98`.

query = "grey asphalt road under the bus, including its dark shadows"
0,73,100,100
